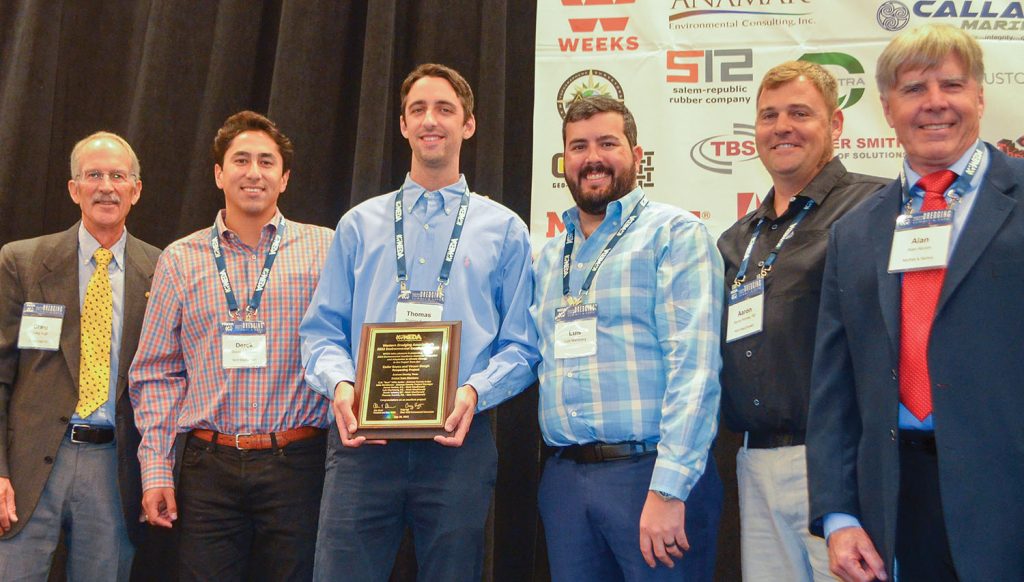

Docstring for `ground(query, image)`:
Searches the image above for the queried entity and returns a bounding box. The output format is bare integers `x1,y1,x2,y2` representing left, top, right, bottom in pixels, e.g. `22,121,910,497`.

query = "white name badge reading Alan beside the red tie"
889,209,953,273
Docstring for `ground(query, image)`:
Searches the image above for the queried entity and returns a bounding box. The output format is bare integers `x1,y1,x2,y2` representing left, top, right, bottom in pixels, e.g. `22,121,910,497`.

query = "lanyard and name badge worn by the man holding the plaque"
394,190,470,323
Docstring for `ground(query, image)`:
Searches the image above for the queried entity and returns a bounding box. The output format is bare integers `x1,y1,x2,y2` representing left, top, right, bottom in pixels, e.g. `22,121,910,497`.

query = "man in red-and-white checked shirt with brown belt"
125,111,331,580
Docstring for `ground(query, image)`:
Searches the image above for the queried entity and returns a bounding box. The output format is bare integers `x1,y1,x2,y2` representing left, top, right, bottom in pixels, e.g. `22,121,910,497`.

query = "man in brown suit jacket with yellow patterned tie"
0,132,160,580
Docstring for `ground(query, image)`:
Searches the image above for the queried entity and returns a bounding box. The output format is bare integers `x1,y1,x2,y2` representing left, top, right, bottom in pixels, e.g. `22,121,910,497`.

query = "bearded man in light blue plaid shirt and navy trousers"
532,96,723,581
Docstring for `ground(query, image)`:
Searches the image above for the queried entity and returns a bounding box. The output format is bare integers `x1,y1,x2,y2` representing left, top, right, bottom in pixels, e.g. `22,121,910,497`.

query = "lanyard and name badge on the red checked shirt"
210,218,286,370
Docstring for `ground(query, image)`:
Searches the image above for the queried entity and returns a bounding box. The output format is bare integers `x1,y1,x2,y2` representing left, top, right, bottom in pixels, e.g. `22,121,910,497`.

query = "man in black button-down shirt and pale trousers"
718,61,885,581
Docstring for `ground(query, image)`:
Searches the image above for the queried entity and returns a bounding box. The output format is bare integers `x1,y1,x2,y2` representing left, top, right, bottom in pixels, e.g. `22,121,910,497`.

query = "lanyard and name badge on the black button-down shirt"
725,199,814,343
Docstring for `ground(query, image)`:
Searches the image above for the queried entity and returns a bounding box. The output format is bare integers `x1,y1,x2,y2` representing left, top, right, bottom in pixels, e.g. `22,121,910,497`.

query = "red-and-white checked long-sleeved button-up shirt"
129,211,333,490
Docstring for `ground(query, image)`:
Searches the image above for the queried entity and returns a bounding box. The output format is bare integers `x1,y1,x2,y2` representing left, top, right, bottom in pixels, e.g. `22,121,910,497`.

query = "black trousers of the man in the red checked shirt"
175,437,326,582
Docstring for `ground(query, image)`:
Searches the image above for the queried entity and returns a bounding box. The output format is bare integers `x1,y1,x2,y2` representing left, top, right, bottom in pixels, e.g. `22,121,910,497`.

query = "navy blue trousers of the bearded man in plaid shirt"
538,455,722,582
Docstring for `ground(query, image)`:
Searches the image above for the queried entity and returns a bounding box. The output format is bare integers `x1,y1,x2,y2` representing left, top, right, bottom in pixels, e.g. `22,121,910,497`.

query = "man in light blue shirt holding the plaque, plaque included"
299,65,539,581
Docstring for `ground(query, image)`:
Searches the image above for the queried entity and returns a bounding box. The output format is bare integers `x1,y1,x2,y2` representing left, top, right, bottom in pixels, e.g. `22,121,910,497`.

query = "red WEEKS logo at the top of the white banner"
558,0,640,52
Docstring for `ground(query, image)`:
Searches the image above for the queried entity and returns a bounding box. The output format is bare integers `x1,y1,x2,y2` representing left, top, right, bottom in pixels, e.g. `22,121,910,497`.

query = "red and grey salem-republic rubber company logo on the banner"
665,48,754,105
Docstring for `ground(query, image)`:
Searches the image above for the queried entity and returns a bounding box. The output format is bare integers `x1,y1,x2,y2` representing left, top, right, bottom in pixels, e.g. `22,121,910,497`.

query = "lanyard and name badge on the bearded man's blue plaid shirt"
554,197,648,360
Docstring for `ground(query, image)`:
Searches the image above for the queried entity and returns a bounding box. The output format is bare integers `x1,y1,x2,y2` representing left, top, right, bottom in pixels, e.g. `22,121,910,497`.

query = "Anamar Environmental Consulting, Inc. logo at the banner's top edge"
669,0,814,31
